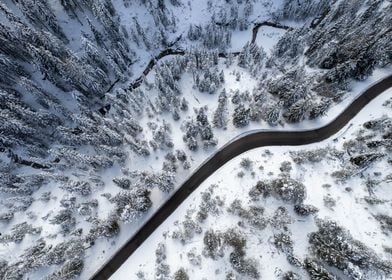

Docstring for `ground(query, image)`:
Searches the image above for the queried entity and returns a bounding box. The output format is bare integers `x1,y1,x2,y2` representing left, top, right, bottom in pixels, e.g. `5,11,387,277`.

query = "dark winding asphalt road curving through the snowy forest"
91,75,392,280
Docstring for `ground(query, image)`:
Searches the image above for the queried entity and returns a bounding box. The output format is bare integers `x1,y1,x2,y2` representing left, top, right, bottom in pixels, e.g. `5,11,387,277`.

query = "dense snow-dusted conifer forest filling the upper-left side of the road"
0,0,392,279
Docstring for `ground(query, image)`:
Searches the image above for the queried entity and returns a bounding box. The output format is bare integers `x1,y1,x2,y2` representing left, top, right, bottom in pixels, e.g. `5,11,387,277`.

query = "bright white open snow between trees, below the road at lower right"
111,89,392,279
